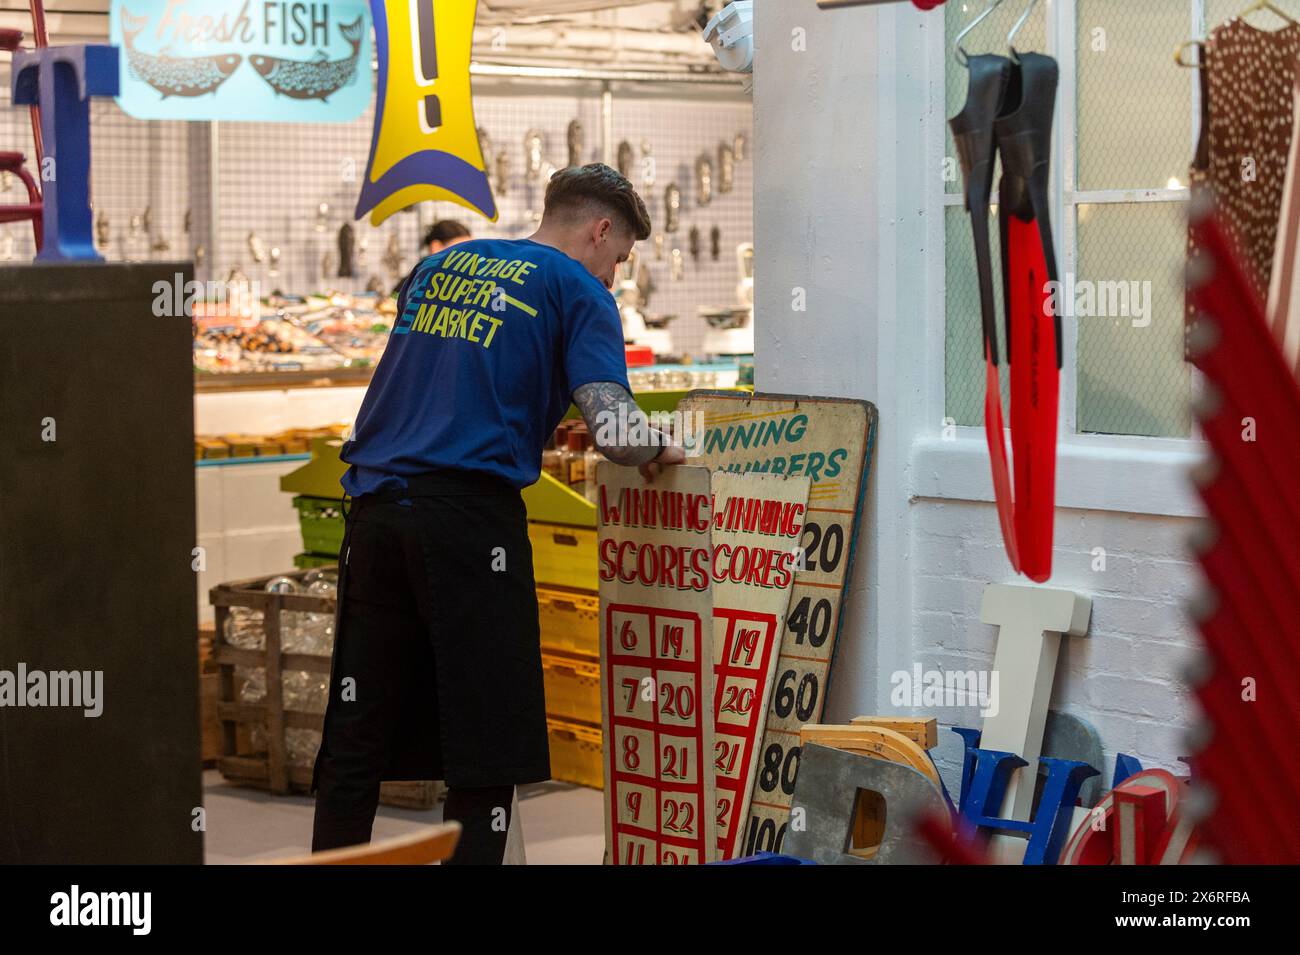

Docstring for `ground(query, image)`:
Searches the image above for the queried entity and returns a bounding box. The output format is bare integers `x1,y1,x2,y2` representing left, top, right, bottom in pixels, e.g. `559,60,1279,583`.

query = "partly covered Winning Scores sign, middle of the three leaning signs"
712,470,811,859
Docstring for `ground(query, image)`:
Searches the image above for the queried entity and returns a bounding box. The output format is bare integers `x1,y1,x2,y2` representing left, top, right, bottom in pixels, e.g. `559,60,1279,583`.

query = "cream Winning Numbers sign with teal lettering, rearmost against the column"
679,391,876,855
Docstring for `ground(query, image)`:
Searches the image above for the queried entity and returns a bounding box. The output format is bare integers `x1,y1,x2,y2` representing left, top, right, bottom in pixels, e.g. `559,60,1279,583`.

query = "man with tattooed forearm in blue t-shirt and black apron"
312,164,684,863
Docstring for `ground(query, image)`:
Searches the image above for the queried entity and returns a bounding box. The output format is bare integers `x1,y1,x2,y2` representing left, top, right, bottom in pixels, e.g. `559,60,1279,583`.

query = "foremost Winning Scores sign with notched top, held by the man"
597,461,718,865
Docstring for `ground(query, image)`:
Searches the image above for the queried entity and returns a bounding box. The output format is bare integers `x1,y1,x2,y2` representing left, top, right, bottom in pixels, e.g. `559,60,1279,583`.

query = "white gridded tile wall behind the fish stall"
0,62,753,352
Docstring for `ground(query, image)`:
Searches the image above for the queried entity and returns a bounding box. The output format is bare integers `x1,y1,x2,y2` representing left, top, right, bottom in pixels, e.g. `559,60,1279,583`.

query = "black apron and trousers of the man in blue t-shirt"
312,473,550,864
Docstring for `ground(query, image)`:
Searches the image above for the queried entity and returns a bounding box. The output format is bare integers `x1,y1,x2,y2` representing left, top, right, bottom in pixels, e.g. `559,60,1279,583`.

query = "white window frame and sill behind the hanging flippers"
911,0,1205,517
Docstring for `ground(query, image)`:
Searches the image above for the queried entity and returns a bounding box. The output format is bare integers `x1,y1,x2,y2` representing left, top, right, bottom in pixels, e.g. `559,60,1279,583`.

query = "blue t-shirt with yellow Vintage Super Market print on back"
342,239,628,496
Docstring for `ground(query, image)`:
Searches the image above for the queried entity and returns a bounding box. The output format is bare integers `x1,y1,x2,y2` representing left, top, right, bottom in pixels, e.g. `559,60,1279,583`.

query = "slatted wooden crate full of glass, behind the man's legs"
208,573,442,809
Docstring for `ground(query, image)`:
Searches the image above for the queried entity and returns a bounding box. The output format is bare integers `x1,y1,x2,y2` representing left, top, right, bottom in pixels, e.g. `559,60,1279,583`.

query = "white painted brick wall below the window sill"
904,500,1200,786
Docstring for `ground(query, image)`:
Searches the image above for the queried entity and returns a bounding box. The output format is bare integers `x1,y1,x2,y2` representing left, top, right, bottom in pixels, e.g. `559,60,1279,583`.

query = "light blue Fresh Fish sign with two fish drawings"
109,0,372,122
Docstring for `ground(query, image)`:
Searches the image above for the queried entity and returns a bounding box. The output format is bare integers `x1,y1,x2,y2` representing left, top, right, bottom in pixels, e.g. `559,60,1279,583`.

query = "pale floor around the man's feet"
203,770,605,865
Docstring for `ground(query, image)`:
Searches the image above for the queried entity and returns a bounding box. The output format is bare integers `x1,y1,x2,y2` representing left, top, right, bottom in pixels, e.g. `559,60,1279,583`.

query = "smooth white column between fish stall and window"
754,0,944,722
